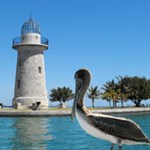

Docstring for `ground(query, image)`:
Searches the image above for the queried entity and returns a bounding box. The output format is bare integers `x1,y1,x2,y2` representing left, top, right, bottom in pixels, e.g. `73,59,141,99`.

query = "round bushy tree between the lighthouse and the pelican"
49,86,74,107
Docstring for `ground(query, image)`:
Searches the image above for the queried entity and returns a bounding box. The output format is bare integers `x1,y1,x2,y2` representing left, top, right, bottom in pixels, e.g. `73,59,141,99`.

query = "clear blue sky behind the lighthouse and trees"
0,0,150,106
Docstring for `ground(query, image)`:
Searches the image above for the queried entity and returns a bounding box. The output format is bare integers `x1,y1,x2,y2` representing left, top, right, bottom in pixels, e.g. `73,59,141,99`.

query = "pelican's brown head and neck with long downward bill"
71,69,91,119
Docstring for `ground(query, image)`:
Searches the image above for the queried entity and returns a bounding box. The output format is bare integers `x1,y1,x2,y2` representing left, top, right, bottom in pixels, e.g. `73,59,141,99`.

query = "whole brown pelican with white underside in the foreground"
72,69,150,150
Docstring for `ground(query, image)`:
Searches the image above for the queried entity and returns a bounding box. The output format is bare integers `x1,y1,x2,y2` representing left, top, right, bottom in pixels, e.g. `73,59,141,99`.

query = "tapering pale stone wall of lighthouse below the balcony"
13,47,48,106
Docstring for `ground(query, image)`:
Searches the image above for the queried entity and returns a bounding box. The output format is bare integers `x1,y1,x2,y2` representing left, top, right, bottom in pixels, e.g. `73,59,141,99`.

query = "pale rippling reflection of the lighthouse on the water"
13,118,52,150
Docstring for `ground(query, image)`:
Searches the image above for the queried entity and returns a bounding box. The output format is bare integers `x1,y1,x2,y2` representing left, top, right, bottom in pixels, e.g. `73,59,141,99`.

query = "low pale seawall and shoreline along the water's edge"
0,107,150,117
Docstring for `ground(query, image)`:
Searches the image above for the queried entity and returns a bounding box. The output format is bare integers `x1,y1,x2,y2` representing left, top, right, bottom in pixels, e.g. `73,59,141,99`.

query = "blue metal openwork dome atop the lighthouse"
21,18,40,35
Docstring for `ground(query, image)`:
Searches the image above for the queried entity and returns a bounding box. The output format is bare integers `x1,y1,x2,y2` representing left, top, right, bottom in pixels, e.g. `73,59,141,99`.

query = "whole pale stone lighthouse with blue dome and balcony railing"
12,18,48,109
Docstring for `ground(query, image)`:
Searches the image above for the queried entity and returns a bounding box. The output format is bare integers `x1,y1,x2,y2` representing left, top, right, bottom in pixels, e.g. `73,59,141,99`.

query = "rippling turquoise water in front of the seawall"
0,114,150,150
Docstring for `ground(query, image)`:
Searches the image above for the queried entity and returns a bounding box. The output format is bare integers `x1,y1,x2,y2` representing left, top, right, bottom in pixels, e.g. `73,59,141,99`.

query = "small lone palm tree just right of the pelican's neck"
87,86,101,108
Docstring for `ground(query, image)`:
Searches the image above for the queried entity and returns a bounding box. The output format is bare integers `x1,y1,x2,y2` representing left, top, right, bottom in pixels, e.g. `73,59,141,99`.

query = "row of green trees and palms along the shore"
49,76,150,107
